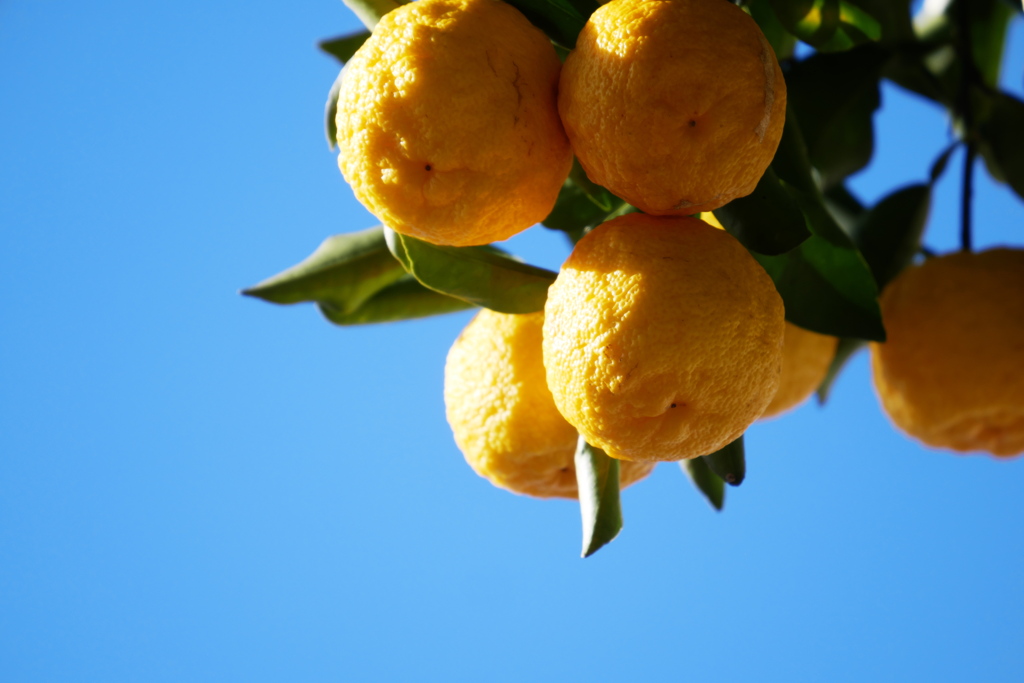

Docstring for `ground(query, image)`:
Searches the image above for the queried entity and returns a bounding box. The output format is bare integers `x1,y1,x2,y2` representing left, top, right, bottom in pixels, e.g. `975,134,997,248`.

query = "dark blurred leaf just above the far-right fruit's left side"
854,183,932,290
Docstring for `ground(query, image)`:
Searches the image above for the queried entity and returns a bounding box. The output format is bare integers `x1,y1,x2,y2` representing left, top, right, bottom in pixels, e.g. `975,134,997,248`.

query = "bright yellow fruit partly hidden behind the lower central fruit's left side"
444,309,653,498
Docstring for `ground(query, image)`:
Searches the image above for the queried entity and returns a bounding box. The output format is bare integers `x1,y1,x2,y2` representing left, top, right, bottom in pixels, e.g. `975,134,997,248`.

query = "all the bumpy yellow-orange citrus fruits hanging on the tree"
323,0,1024,507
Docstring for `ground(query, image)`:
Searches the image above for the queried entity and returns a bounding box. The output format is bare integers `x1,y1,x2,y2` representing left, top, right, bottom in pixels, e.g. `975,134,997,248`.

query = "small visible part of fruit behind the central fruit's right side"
761,323,839,419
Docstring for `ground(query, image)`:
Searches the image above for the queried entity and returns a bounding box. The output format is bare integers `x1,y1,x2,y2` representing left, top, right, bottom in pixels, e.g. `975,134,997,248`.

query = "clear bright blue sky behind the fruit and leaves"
0,0,1024,682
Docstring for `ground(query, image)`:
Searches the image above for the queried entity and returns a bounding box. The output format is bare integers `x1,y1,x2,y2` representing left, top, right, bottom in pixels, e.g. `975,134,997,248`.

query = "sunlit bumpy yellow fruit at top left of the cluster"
337,0,572,246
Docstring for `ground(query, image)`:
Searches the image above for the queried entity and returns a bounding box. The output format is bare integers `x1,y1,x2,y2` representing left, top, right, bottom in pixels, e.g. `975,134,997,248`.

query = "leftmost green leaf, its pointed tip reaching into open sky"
242,227,406,313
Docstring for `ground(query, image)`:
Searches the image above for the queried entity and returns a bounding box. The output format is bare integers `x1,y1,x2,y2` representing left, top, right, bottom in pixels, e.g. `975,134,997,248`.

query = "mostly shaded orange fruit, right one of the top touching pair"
558,0,785,215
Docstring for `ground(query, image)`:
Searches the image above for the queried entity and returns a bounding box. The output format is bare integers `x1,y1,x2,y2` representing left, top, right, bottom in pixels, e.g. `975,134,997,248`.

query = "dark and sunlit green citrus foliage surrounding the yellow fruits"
244,0,1024,556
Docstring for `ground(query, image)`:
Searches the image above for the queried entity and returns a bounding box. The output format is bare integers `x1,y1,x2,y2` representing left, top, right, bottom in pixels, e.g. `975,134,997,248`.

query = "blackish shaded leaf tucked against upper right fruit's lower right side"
715,168,811,255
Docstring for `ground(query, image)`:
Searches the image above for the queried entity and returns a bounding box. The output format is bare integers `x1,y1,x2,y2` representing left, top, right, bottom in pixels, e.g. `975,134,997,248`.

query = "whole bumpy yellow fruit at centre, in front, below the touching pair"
544,214,784,461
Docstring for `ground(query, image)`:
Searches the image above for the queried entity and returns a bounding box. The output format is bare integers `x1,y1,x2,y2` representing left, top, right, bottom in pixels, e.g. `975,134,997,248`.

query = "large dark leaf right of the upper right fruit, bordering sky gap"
785,45,888,186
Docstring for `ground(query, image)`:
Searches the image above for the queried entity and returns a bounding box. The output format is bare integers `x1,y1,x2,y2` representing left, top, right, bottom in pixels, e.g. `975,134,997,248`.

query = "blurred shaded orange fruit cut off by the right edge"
871,249,1024,456
